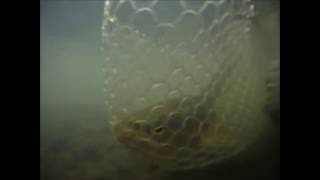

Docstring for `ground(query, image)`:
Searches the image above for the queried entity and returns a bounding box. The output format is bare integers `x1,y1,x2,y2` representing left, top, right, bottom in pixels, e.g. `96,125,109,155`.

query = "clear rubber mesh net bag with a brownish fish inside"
102,0,266,169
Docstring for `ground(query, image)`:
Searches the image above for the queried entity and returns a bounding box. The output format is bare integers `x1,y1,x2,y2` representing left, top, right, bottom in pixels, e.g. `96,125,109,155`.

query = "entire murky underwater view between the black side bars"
40,0,280,180
